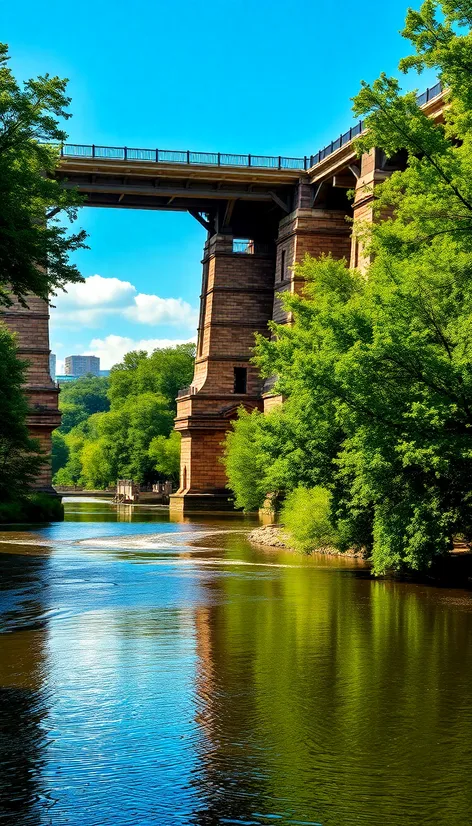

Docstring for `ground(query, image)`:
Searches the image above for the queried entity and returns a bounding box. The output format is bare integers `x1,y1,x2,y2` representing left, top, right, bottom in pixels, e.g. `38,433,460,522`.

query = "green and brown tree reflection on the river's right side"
192,539,472,826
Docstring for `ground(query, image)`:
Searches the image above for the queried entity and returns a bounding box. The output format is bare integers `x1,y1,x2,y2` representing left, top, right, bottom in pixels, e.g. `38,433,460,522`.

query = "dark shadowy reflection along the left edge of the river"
0,548,49,826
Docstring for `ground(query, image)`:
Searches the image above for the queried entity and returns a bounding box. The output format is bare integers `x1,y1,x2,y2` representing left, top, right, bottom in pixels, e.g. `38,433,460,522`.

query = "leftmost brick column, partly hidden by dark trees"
0,296,61,493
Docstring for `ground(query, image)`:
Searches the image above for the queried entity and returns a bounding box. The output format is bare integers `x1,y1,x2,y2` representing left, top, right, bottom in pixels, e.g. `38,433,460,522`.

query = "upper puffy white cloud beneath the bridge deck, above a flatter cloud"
51,275,198,330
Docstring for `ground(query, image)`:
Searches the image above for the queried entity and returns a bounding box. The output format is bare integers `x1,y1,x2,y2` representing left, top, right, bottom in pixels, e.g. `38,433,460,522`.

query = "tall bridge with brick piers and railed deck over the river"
3,84,444,512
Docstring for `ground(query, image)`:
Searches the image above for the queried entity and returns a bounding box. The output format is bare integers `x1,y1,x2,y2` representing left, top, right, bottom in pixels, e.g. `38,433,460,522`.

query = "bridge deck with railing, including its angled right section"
57,84,444,222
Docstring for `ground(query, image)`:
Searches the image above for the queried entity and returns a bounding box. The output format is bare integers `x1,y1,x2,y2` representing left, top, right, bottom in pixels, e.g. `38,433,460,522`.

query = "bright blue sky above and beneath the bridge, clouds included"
1,0,434,367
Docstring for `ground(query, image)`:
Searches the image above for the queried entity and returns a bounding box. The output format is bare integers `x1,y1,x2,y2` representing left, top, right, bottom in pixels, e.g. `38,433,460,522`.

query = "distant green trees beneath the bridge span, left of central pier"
53,344,195,488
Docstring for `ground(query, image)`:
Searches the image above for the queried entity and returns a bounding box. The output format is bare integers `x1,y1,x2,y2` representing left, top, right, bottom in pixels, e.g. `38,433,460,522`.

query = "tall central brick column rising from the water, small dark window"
171,234,275,512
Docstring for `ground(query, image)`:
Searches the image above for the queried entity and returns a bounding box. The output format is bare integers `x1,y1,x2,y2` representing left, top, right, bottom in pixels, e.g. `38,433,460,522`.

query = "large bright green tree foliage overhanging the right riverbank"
223,0,472,572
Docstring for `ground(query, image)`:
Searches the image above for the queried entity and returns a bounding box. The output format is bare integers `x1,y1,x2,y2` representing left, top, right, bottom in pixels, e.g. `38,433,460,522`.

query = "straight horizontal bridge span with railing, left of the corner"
57,144,304,236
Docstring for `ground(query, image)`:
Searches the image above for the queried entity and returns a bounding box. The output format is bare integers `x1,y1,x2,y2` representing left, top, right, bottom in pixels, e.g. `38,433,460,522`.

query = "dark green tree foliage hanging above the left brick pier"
0,43,85,304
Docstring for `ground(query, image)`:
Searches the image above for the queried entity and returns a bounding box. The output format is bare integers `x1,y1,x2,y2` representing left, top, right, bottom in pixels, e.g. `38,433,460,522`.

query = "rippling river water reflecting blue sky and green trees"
0,500,472,826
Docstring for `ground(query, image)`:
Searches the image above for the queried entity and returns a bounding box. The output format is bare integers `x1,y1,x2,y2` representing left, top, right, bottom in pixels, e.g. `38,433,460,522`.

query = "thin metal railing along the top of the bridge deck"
61,83,442,175
